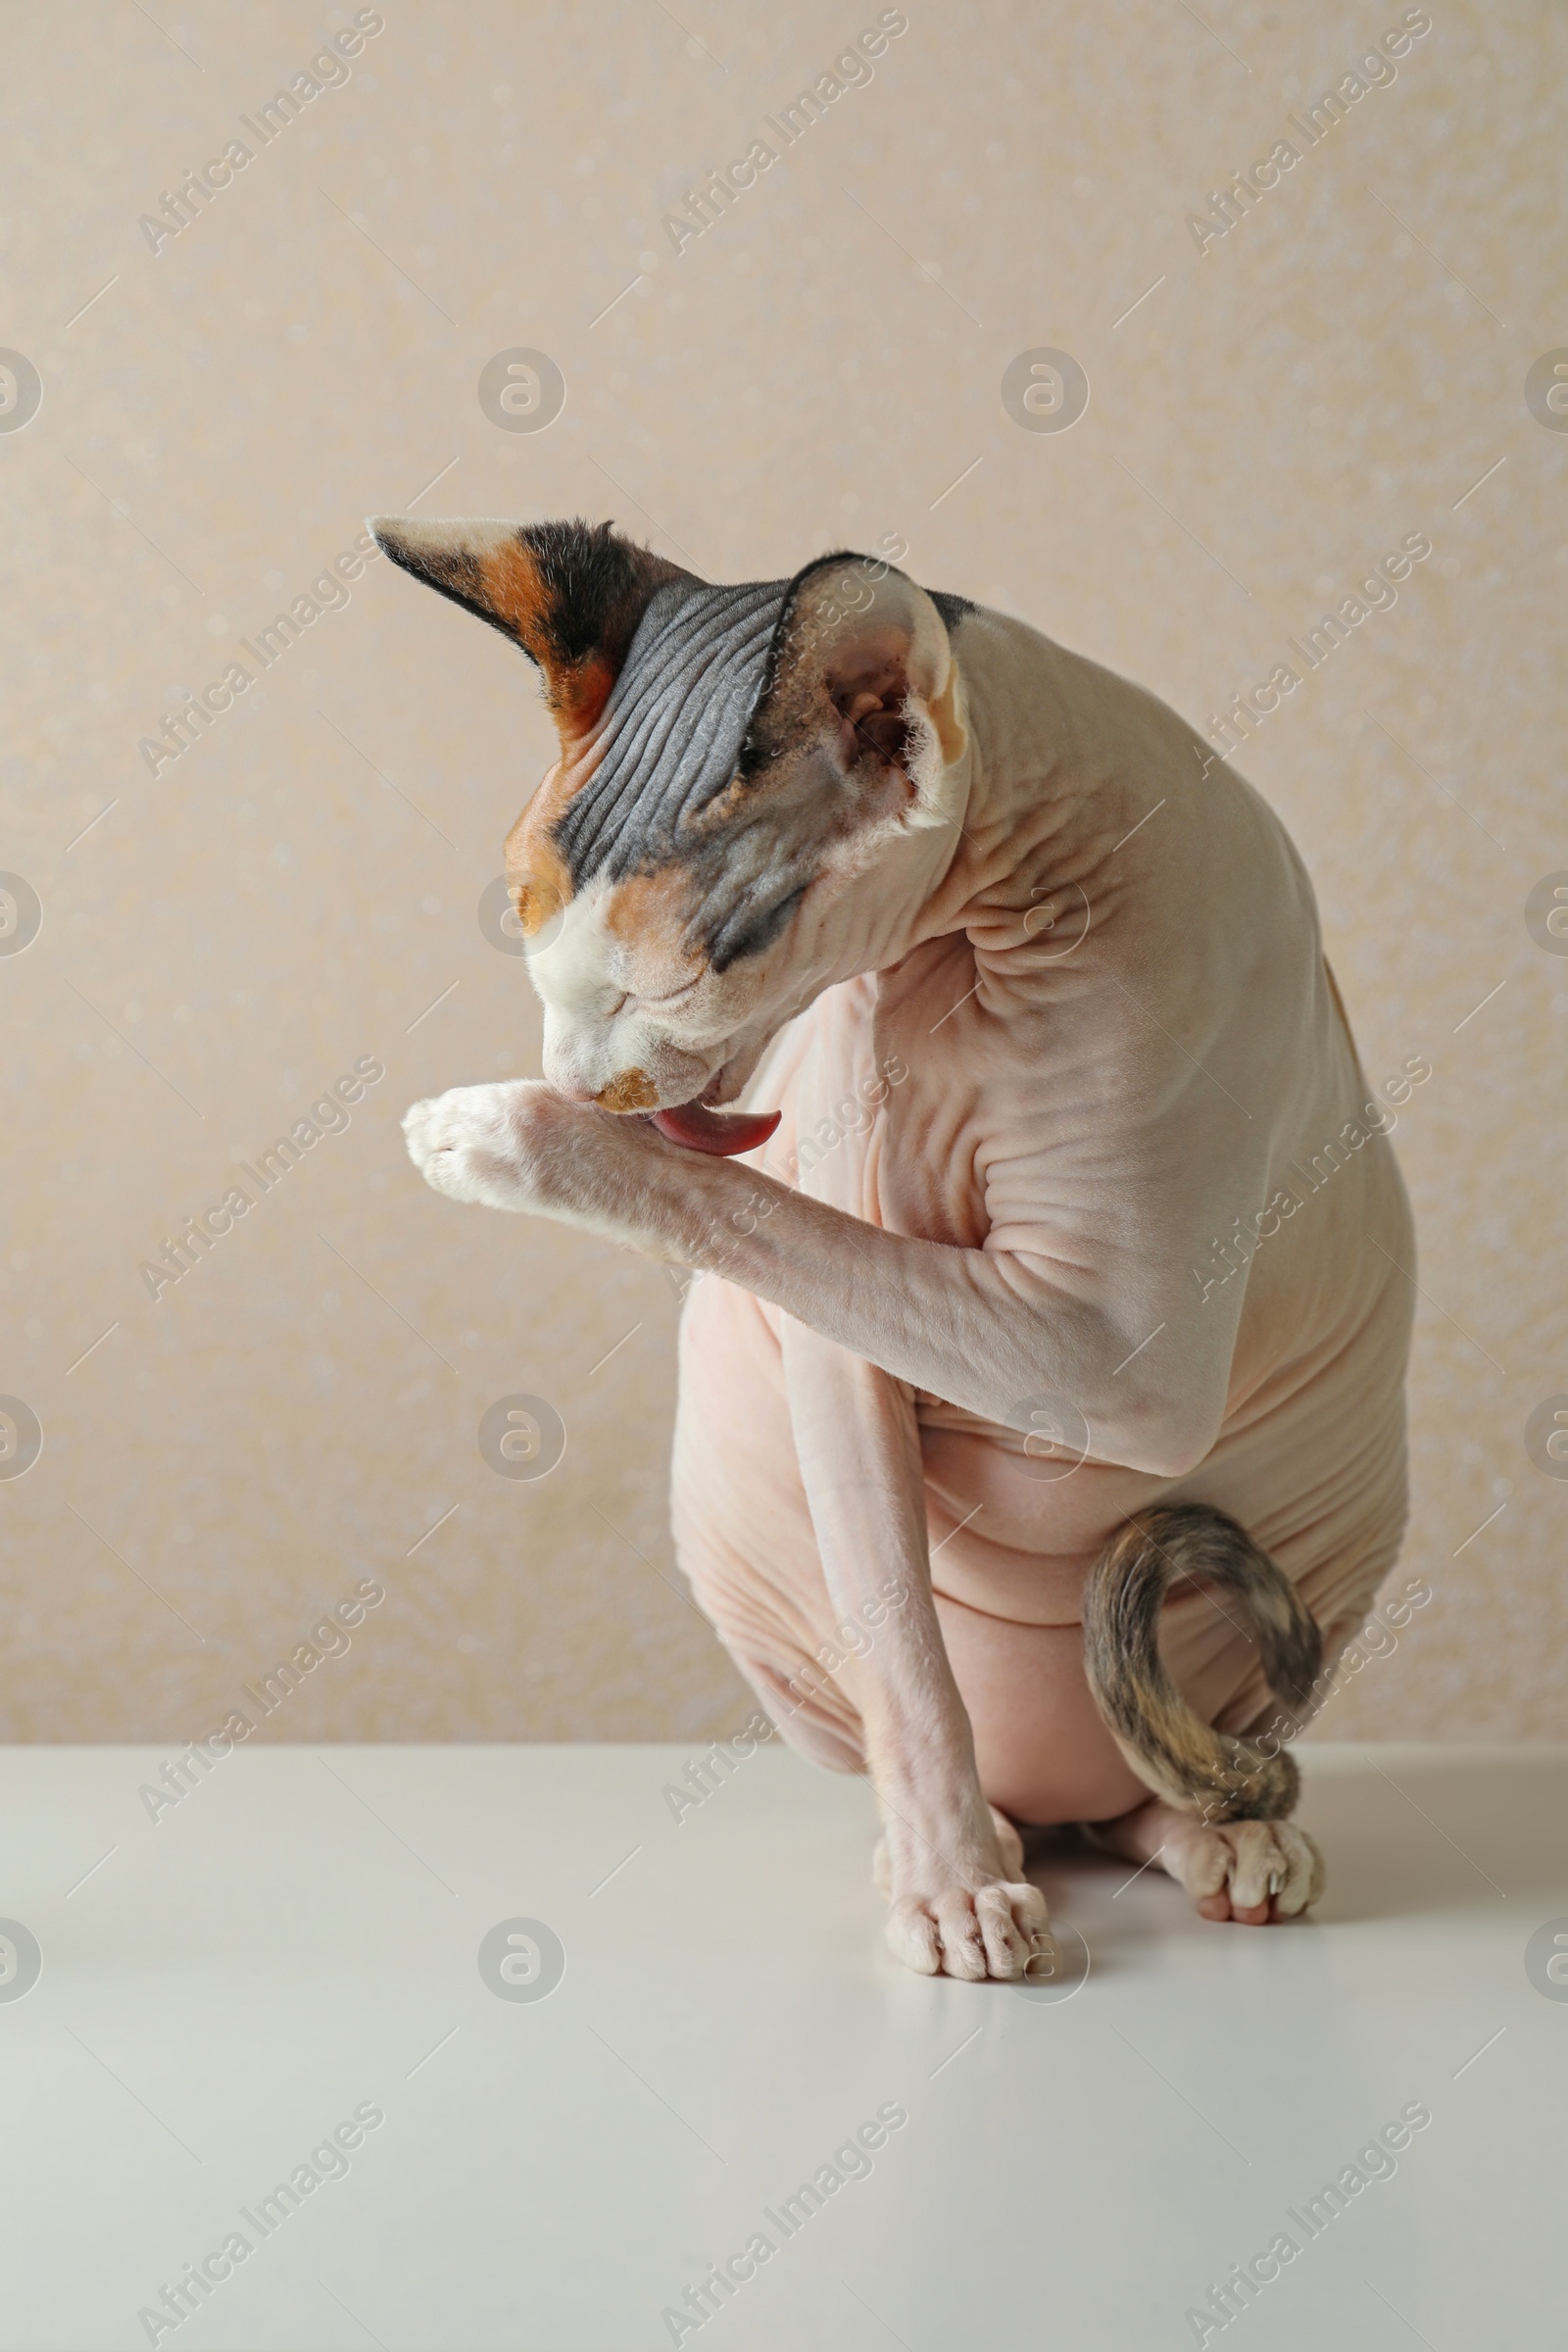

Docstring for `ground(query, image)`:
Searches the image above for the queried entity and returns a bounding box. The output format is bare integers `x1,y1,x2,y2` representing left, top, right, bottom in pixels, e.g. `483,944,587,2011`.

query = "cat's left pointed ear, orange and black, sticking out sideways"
369,515,691,751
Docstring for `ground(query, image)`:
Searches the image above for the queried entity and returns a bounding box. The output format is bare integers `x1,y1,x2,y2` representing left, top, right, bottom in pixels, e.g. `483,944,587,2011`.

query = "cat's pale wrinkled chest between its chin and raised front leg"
757,939,995,1249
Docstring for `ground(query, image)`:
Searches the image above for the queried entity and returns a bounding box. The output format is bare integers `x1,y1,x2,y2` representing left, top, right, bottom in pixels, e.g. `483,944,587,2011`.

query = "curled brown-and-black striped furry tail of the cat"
1084,1503,1324,1821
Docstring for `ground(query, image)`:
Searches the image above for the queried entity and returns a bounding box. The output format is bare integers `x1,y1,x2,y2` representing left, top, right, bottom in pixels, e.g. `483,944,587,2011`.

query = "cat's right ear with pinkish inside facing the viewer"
750,555,968,816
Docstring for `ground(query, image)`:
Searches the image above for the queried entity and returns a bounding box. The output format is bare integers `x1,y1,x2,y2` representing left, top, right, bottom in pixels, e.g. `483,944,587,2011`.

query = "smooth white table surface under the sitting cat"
0,1745,1568,2352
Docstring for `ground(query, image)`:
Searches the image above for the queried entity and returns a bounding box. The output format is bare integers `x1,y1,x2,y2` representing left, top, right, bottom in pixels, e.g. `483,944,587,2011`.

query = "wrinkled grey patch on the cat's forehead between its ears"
555,581,795,889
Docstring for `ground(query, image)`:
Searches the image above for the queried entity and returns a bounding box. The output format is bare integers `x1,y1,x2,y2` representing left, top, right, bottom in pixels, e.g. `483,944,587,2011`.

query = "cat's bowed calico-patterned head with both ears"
371,517,966,1110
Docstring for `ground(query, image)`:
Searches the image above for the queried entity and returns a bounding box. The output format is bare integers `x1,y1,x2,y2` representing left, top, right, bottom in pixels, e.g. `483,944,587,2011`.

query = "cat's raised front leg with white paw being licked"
402,1080,1239,1477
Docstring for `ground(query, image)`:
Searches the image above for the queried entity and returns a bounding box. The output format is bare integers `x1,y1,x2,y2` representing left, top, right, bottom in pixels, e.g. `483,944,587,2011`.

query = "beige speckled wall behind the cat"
0,0,1568,1740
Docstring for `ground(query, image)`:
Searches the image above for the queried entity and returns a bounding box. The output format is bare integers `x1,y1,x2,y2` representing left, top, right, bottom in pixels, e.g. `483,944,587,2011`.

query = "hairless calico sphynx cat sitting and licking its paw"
371,519,1413,1981
